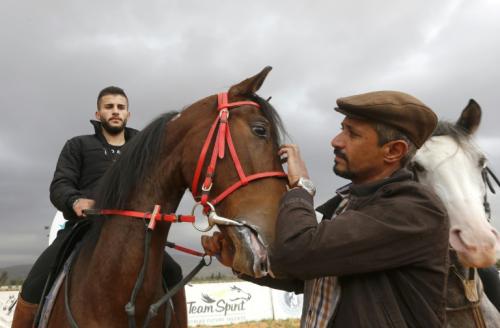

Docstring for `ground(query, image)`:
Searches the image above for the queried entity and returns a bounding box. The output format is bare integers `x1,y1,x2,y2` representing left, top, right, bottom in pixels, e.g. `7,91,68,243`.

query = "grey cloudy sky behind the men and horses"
0,0,500,267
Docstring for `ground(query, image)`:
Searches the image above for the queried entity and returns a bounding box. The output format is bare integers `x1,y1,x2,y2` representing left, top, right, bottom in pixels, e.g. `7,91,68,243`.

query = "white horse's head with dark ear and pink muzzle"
412,100,500,267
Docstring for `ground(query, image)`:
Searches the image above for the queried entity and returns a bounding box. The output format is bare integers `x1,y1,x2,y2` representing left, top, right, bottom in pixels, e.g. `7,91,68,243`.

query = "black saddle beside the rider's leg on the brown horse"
34,219,92,327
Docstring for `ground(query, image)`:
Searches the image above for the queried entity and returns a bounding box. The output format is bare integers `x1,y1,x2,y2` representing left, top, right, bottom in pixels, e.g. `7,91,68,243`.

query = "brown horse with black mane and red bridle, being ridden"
41,67,286,327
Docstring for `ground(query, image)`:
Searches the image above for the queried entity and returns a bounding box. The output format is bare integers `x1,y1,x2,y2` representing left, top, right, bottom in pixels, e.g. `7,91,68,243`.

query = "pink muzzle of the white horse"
450,227,500,268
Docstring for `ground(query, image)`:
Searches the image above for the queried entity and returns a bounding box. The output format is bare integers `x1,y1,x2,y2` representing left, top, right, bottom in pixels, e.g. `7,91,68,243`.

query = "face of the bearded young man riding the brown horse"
95,95,130,134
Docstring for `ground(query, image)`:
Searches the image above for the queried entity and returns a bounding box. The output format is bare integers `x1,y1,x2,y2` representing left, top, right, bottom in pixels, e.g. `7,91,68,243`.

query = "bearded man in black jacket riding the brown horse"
12,86,185,327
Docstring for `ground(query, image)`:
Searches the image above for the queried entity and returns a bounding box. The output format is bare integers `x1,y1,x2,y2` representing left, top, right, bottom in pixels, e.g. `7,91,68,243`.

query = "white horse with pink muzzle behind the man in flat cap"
410,100,500,328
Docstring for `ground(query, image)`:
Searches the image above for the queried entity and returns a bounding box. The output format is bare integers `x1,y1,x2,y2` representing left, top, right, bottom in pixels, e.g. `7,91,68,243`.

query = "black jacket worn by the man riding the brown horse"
50,120,138,226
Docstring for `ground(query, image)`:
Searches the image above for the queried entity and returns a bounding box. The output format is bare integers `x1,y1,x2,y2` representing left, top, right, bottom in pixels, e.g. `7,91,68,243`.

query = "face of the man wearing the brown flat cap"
331,117,384,184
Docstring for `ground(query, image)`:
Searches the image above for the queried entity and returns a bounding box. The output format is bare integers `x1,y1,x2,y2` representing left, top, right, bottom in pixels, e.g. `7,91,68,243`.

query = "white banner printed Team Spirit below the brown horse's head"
186,282,273,326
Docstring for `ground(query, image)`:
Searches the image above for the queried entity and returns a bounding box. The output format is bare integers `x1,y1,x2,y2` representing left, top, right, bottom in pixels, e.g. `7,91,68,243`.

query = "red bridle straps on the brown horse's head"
191,92,287,208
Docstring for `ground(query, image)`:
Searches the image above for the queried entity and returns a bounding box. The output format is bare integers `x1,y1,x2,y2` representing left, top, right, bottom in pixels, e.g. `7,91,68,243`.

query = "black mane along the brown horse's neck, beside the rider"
96,112,178,209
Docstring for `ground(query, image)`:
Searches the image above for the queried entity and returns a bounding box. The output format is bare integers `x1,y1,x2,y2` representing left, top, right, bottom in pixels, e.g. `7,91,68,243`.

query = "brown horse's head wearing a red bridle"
174,67,286,277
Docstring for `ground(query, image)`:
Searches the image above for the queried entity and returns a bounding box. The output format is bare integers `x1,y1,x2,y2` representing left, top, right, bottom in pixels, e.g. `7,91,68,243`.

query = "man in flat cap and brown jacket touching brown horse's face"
202,91,449,328
